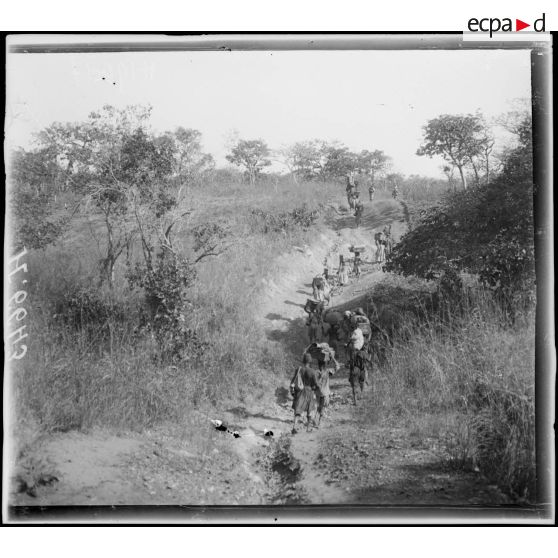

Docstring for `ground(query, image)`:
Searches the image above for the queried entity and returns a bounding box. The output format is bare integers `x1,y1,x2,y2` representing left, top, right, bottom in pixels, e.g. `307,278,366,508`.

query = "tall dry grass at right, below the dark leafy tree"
362,282,536,502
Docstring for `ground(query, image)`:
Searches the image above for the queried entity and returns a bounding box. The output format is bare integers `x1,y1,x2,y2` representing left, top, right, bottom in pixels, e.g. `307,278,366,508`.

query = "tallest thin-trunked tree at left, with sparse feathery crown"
32,105,174,287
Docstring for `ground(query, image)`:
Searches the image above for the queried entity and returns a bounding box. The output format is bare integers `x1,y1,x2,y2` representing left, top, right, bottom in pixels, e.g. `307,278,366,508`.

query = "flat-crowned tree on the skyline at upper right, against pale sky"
417,114,486,189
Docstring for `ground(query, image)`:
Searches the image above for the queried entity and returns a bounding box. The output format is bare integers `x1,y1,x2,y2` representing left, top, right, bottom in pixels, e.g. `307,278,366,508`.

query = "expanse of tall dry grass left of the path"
12,175,338,442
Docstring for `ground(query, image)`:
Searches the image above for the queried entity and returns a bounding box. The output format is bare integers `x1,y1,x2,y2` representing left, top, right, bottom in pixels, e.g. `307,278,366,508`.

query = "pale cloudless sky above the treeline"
6,50,531,177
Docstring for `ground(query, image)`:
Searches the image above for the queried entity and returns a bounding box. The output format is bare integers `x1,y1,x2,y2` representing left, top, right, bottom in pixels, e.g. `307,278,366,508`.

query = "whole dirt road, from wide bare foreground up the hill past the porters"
13,200,516,516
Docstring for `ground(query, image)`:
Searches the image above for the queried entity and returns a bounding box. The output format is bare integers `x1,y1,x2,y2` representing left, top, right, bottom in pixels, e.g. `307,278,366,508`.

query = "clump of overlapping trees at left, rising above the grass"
20,105,221,287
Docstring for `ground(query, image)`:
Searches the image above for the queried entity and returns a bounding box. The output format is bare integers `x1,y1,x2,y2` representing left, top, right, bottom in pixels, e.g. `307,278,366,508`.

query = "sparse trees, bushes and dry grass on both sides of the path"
7,106,536,503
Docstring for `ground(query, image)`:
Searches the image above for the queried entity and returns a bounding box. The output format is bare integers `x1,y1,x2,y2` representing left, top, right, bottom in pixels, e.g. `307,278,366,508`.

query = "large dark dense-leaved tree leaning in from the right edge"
386,113,534,306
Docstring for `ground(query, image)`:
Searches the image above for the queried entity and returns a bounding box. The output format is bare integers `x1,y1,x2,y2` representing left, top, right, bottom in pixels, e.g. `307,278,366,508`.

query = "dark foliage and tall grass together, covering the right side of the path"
370,118,536,503
